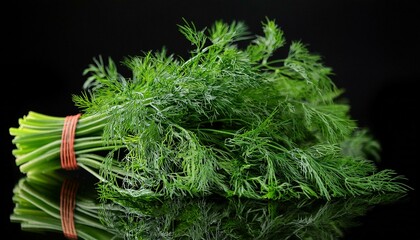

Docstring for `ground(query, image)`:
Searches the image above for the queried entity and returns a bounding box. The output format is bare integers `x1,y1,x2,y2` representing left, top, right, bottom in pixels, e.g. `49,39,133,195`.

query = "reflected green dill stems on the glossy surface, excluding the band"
10,172,115,240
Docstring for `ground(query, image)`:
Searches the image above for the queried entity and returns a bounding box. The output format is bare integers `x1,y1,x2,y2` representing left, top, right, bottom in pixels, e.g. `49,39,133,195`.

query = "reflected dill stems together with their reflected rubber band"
10,172,120,240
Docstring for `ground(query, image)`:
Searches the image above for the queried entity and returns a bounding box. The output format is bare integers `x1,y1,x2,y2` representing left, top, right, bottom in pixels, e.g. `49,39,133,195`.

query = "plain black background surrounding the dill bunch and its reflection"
0,0,420,239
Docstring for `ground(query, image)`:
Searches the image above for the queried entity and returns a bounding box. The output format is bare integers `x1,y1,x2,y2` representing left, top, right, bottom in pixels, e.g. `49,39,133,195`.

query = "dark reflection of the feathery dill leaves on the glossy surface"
101,194,403,240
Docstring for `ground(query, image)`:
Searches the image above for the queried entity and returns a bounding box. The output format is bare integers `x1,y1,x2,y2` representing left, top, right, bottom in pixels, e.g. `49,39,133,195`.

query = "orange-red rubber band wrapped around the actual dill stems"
60,113,80,170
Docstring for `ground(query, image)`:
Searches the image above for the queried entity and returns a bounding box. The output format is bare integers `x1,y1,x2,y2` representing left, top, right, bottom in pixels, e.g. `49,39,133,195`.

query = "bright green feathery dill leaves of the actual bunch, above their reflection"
11,19,410,200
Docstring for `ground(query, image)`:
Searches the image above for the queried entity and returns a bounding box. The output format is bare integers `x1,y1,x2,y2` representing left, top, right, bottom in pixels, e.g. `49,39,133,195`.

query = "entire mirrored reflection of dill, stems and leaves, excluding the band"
10,172,404,240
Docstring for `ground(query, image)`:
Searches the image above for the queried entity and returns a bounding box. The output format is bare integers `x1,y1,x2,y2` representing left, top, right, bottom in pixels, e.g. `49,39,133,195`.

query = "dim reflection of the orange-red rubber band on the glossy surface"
60,179,79,239
